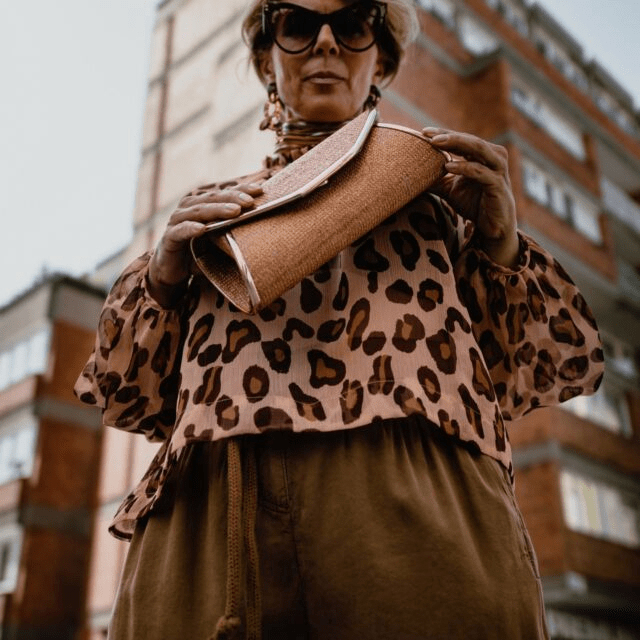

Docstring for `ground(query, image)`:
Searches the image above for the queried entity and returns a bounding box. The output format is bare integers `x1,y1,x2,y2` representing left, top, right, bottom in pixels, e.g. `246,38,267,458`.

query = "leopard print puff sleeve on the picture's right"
454,233,604,420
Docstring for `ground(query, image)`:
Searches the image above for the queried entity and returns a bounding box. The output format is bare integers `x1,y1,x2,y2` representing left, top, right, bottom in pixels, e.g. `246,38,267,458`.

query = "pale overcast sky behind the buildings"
0,0,640,306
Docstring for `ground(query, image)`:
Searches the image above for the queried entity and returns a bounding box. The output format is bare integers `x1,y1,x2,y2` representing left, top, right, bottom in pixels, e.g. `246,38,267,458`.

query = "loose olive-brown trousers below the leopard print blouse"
109,417,547,640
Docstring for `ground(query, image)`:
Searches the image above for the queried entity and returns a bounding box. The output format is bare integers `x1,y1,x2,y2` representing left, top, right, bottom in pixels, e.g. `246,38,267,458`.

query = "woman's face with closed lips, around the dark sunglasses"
262,0,383,122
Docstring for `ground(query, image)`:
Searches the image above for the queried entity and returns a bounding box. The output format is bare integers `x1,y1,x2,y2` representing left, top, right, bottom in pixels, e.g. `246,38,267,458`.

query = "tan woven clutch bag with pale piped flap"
191,110,446,313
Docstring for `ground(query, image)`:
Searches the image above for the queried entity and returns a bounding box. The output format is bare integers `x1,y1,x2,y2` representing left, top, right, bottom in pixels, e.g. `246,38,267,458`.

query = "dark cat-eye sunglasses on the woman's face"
270,3,380,53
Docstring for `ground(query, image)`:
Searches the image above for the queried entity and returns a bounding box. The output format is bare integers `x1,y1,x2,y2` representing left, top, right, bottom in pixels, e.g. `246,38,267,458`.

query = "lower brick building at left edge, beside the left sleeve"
0,276,104,640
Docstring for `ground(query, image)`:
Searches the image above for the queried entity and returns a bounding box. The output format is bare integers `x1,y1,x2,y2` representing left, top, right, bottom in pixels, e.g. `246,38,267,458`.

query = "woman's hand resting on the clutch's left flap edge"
149,184,262,307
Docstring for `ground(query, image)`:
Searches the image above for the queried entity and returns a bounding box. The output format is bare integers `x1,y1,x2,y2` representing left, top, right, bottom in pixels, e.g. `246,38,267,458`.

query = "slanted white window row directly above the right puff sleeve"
522,158,602,244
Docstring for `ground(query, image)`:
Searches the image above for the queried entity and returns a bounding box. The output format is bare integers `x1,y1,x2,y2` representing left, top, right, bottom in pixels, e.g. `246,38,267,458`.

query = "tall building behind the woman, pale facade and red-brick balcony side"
57,0,640,640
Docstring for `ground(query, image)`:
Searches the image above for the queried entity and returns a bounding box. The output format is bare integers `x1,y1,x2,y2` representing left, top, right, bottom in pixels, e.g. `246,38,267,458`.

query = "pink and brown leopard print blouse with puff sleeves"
76,167,604,538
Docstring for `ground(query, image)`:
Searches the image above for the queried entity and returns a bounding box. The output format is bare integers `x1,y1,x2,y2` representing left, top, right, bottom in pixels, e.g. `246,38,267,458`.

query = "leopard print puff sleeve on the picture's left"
74,253,182,442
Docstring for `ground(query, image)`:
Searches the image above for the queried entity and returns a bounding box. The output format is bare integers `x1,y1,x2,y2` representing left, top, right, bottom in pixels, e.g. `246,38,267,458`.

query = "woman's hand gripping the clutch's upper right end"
422,127,519,267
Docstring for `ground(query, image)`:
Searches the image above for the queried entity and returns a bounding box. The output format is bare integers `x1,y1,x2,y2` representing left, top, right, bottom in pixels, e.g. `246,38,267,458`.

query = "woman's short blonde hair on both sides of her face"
242,0,420,84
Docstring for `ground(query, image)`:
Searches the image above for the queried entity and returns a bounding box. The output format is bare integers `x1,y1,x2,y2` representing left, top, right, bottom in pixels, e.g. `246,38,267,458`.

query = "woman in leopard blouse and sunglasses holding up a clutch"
76,0,602,640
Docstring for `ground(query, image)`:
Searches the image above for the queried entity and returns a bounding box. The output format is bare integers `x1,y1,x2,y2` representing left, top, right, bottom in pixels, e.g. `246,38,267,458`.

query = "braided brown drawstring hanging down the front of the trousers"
210,438,262,640
